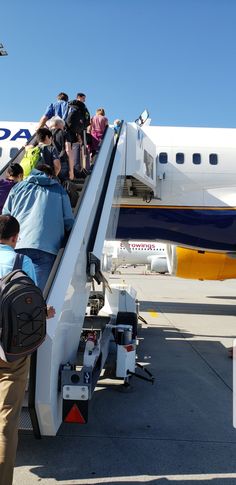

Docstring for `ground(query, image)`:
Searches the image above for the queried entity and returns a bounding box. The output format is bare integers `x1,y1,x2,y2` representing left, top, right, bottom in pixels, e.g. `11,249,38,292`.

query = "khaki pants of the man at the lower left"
0,357,30,485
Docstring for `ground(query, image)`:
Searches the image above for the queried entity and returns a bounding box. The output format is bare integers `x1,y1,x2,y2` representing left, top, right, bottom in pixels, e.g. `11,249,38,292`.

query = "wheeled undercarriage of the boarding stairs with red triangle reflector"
60,285,137,423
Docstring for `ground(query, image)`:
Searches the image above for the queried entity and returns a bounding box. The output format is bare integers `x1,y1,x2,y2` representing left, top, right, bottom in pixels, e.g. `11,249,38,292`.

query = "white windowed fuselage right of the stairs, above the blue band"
127,124,236,207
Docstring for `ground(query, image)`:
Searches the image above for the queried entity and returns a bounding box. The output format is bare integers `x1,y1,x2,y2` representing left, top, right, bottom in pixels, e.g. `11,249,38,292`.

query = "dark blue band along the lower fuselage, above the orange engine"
116,206,236,251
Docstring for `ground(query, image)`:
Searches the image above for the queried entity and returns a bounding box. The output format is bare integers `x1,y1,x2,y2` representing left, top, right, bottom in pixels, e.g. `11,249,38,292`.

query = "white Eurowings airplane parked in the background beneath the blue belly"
102,241,168,273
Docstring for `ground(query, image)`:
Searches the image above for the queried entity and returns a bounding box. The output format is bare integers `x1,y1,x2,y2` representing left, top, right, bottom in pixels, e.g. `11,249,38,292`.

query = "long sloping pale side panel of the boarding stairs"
2,128,121,436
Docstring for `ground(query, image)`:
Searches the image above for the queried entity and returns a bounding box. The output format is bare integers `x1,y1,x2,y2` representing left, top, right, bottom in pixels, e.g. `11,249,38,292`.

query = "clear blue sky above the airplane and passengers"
0,0,236,127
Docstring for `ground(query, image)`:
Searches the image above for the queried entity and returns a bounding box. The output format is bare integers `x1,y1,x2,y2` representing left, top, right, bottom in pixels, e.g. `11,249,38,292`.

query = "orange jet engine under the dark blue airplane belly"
166,244,236,280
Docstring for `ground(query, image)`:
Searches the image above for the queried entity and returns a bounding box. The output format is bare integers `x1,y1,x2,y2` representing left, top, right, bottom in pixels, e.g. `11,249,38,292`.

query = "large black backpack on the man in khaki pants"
0,254,47,362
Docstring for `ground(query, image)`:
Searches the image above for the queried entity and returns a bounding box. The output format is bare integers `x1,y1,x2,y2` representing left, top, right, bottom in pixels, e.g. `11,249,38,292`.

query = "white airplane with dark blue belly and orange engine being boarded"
0,116,236,280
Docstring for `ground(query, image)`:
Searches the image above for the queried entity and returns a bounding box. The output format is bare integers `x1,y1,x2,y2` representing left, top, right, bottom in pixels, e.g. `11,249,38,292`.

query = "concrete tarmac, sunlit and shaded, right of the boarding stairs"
14,267,236,485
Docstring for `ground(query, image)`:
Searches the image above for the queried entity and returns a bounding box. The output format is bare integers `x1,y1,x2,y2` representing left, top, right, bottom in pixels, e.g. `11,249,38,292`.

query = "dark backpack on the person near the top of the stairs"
65,100,88,135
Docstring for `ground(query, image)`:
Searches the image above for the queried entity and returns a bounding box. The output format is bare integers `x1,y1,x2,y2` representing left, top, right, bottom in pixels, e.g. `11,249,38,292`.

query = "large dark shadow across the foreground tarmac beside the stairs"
14,318,236,485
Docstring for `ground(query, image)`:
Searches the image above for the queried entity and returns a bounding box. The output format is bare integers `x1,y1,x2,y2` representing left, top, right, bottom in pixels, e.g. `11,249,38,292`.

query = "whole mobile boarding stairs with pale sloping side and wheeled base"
1,119,157,437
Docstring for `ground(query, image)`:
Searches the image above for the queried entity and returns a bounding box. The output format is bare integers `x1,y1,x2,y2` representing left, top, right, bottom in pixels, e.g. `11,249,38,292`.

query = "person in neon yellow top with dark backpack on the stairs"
21,128,61,178
